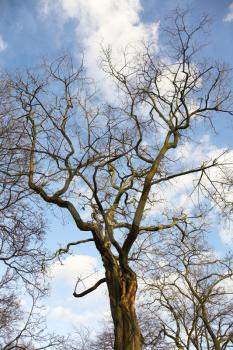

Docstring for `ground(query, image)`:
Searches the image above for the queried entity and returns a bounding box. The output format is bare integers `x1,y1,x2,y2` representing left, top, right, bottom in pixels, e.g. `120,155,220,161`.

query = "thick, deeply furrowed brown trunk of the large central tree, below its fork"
104,262,143,350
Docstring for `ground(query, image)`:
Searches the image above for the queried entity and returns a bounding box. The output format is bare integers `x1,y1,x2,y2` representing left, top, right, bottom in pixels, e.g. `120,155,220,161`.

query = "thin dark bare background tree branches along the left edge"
0,76,65,350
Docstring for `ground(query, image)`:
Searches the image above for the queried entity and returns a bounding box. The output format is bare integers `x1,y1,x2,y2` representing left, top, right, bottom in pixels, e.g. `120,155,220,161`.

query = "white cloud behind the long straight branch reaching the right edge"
147,135,233,223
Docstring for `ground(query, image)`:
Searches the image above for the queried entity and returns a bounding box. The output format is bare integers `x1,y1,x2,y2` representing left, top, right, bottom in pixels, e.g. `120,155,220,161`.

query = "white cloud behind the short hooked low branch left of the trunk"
46,255,109,334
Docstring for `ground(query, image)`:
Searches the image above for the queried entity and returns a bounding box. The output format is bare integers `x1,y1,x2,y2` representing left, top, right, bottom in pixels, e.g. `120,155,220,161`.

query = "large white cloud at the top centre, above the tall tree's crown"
40,0,159,98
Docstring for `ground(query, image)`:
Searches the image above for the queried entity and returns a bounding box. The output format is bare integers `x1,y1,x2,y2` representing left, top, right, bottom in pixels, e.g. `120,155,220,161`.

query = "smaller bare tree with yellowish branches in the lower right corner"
139,220,233,350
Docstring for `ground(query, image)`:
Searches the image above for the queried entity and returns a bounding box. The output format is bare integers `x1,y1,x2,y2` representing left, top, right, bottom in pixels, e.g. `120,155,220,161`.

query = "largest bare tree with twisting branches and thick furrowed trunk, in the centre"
5,10,232,350
